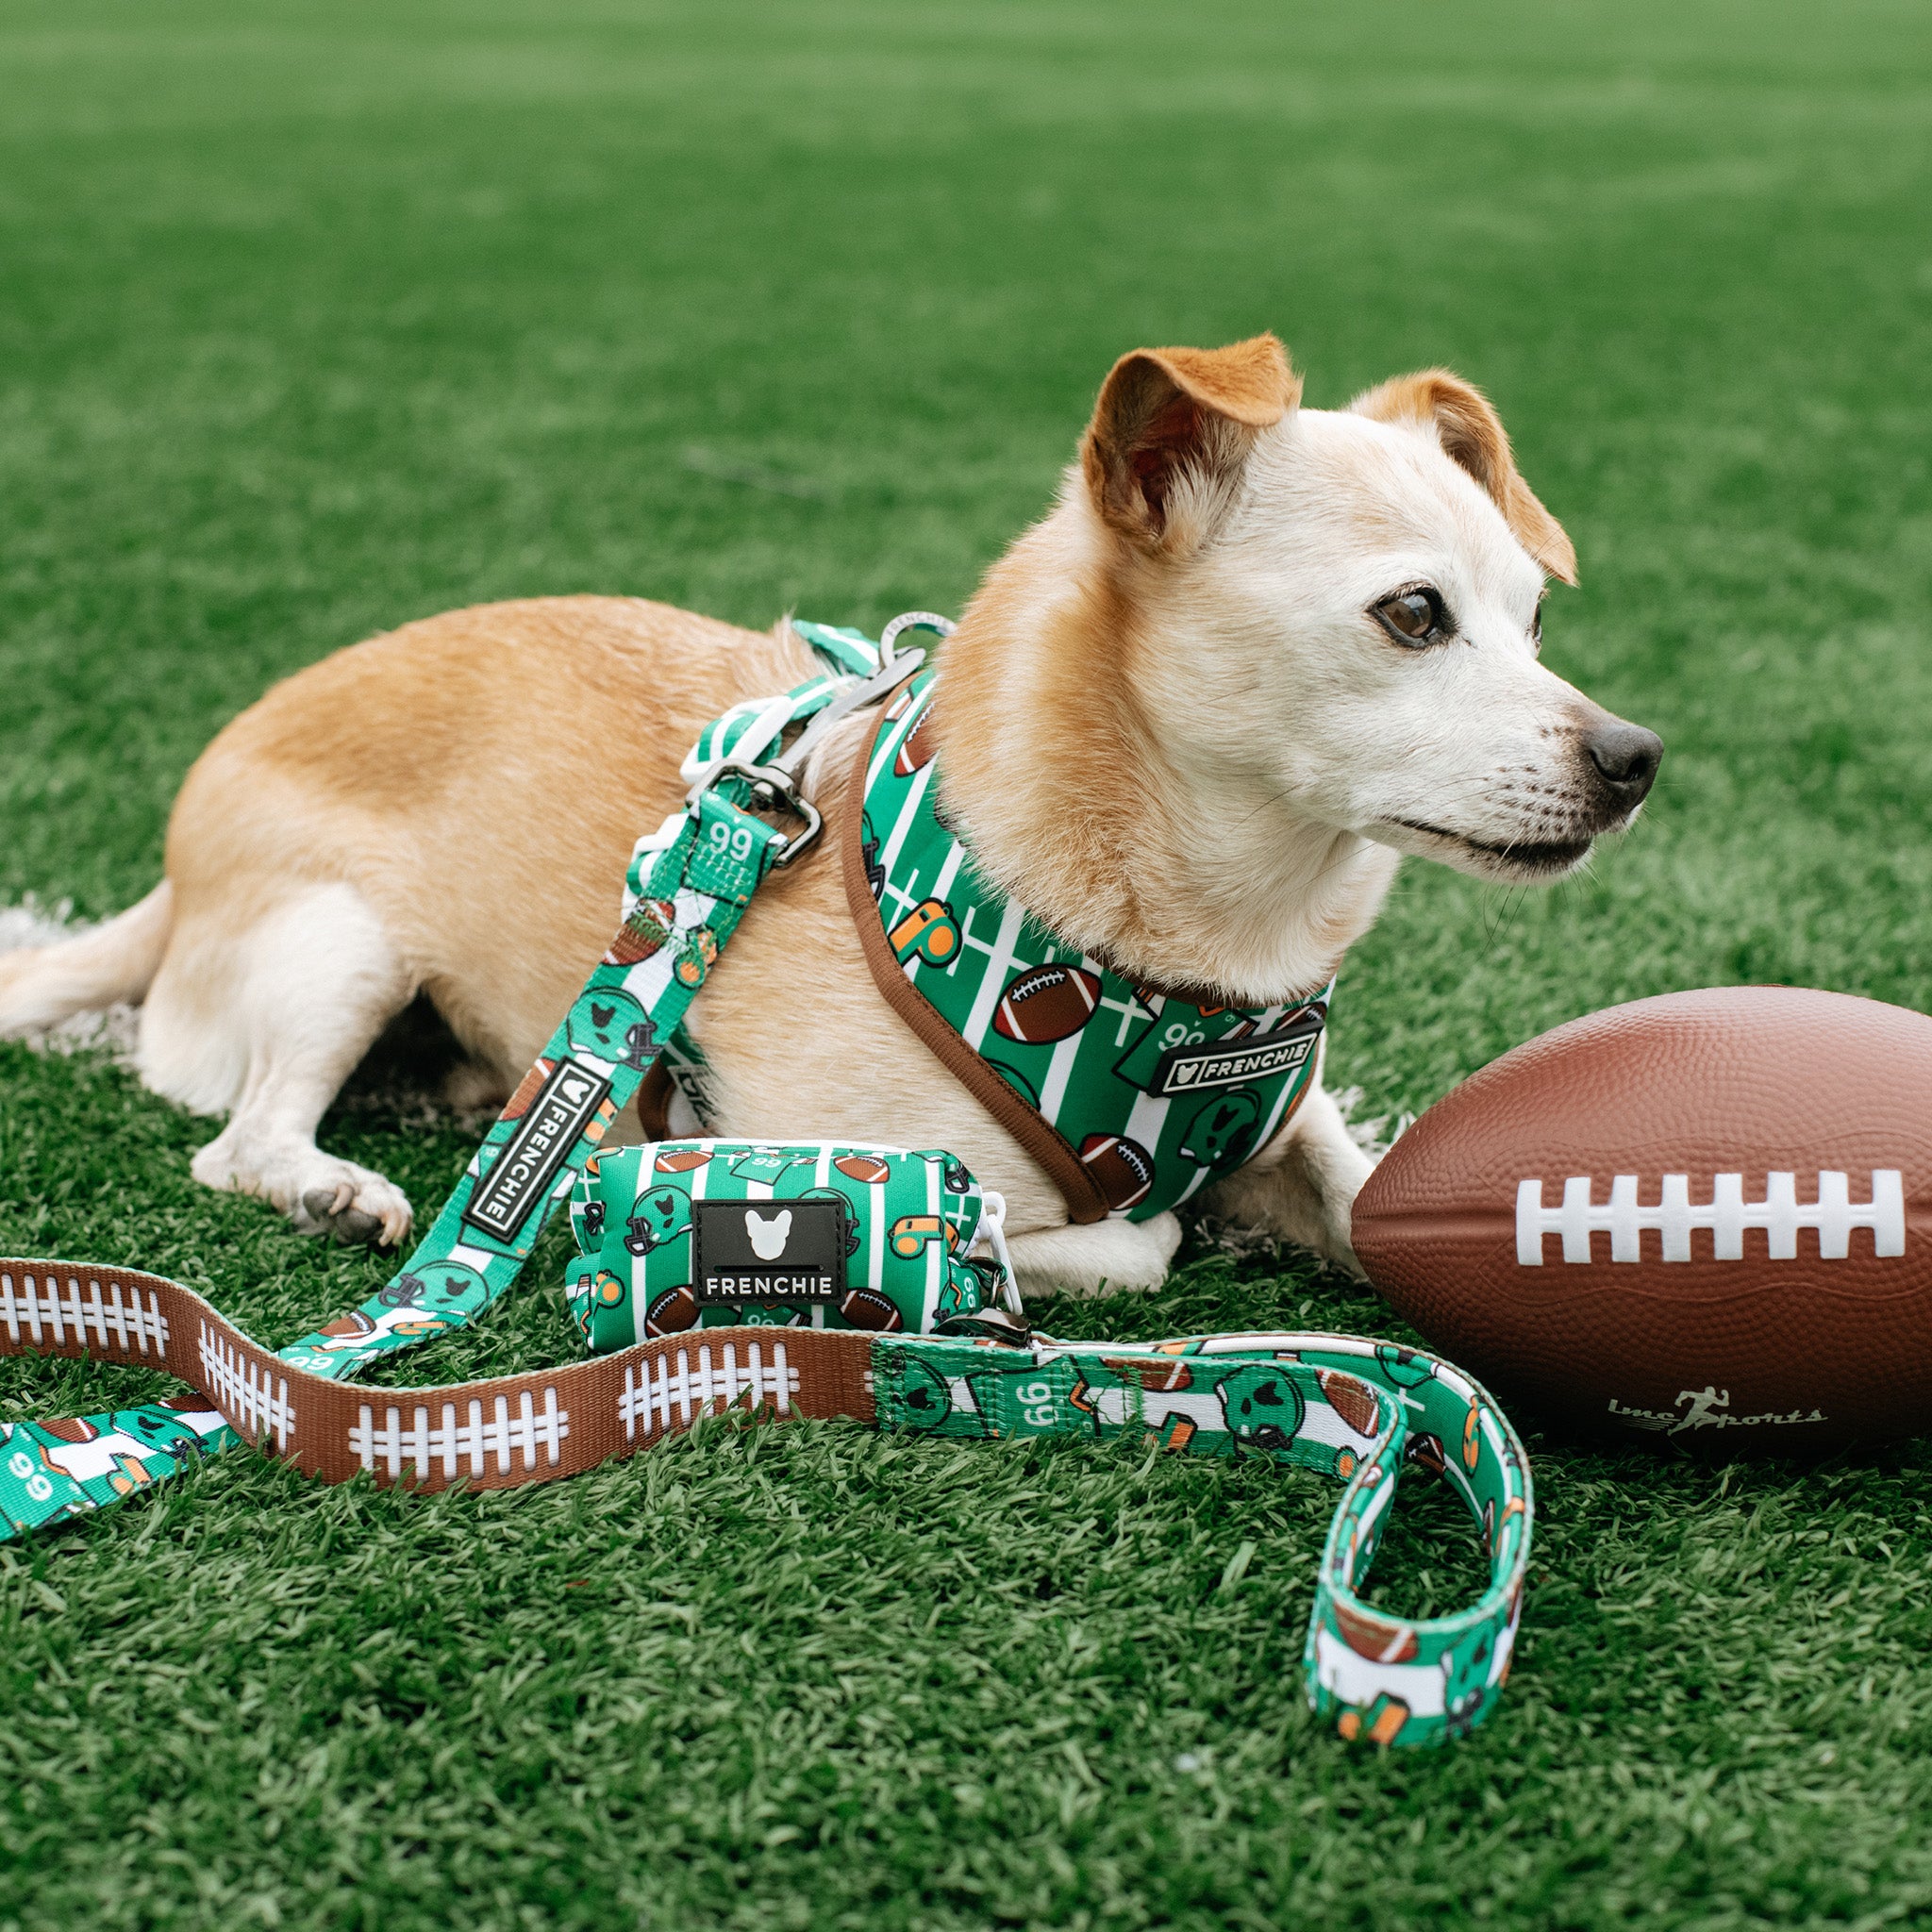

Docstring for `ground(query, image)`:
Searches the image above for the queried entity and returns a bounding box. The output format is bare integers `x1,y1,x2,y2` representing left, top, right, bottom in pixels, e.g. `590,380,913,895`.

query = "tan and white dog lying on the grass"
0,336,1661,1292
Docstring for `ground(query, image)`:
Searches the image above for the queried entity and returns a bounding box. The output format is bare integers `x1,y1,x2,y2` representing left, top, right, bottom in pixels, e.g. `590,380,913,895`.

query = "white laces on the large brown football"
1517,1167,1905,1267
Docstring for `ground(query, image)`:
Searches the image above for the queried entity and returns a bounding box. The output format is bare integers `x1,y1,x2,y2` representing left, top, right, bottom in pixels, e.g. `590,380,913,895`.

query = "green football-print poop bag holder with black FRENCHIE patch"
564,1140,1020,1355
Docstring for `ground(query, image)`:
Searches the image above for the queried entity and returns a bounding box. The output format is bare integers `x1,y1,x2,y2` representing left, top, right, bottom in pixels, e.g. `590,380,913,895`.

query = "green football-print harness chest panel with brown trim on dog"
846,671,1335,1221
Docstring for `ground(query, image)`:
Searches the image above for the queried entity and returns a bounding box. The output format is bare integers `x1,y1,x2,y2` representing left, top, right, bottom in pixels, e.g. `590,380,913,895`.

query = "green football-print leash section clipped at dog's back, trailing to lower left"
0,612,927,1540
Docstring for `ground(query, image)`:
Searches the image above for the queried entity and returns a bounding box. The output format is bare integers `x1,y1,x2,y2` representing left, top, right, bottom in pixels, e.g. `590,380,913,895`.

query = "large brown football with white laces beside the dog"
1355,988,1932,1451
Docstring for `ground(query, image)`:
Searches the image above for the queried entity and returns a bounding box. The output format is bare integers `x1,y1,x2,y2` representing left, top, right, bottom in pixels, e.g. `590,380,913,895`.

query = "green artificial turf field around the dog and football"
0,0,1932,1932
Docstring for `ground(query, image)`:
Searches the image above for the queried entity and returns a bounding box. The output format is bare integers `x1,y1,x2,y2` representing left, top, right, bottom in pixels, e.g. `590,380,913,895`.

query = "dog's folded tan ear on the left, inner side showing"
1080,336,1302,551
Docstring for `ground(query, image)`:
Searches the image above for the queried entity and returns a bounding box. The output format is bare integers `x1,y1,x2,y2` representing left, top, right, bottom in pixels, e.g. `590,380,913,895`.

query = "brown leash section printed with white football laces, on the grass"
0,1261,875,1490
